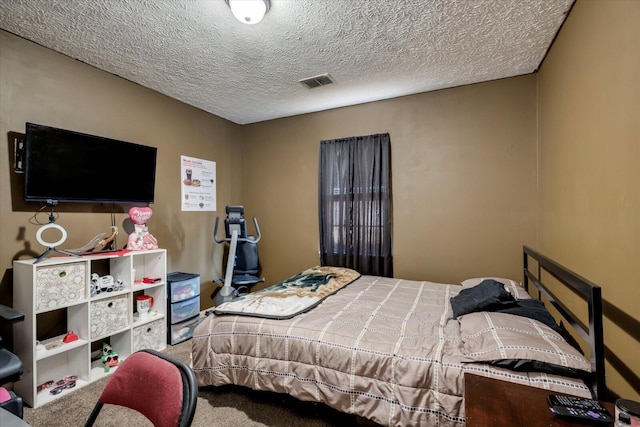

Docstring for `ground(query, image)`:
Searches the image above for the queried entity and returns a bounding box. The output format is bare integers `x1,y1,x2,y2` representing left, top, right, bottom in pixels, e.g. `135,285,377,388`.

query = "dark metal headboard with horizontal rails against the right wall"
522,246,607,399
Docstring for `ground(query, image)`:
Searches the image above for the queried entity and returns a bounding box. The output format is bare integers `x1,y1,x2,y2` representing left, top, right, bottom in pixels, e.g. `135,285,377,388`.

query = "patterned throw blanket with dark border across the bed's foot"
213,266,360,319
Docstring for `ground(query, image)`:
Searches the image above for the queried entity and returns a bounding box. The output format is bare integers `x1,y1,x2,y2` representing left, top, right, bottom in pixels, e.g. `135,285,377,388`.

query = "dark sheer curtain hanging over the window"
318,133,393,277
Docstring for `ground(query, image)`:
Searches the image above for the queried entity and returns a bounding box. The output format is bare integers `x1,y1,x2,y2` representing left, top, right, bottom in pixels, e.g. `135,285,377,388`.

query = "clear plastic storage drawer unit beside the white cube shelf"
167,272,200,345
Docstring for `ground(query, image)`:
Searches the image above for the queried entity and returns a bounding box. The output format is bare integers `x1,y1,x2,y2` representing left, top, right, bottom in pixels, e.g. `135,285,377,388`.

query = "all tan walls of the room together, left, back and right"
0,0,640,399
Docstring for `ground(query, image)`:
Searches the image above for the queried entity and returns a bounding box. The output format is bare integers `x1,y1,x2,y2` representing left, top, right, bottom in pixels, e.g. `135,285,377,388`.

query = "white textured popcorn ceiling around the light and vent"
0,0,574,124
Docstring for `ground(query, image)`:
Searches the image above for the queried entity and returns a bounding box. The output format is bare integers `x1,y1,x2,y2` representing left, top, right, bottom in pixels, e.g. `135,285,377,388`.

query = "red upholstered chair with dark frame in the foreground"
85,350,198,427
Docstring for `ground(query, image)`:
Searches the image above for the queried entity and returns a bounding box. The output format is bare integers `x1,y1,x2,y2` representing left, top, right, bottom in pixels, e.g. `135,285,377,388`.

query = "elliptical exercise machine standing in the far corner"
211,206,265,305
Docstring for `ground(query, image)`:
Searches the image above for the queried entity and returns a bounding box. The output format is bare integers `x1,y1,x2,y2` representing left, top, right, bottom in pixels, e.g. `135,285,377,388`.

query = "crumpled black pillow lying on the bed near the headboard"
451,279,515,318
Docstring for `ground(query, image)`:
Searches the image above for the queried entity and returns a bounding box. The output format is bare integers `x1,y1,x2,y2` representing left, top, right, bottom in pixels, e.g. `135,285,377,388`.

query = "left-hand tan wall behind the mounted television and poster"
0,31,242,307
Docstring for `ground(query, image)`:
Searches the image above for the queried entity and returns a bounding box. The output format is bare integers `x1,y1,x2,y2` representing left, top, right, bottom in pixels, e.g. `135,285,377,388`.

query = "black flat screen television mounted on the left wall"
24,123,157,204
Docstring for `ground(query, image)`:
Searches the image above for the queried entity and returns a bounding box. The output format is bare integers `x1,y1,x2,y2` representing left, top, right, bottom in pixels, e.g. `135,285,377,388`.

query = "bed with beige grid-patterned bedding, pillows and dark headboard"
192,246,605,427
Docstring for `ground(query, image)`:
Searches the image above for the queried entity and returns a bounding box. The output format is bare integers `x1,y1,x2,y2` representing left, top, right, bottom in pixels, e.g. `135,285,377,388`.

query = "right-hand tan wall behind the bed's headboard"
538,0,640,400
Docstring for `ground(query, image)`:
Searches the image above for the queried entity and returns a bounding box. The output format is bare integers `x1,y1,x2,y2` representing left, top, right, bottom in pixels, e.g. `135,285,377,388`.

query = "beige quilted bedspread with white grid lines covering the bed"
192,276,590,427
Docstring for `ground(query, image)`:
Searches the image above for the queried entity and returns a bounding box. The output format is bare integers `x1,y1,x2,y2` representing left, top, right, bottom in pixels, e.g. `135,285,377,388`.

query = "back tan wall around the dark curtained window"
242,76,537,290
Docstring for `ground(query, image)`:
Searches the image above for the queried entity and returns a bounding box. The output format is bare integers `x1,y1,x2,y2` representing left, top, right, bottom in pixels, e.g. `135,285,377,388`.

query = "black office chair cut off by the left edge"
0,304,24,418
